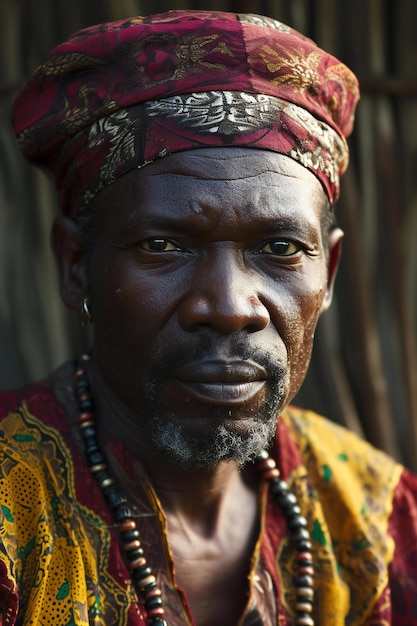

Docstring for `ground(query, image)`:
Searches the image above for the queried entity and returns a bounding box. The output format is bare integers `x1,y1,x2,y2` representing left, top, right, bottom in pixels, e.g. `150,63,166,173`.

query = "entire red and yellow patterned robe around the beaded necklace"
0,368,417,626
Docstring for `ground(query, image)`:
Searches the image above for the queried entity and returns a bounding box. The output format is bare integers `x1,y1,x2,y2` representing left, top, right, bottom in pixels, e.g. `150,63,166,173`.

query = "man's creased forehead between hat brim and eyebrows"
96,148,327,224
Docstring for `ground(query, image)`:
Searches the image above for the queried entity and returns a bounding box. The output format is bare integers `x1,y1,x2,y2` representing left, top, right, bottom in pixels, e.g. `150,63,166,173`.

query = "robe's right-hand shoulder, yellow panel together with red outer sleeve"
278,407,417,624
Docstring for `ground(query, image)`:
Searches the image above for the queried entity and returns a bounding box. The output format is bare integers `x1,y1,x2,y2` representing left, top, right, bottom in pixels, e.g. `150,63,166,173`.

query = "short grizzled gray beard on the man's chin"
148,383,285,470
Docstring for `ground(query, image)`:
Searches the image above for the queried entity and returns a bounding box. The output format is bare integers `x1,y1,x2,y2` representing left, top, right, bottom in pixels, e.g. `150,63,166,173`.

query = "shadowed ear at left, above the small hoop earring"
51,216,88,311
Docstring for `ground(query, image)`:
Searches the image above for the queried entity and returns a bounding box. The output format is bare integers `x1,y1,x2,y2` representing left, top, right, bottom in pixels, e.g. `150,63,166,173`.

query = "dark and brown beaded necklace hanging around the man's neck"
74,354,314,626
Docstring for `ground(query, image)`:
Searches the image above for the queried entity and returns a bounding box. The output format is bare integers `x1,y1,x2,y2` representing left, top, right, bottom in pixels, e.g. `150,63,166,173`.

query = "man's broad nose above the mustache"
179,254,270,334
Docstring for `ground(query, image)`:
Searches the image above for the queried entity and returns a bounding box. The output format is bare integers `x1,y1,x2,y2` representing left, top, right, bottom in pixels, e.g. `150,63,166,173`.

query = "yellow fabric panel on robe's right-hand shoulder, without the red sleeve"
281,408,403,626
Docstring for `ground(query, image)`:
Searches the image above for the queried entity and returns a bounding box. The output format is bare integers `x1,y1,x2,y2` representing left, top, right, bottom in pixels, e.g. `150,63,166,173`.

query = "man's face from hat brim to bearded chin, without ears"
85,148,338,466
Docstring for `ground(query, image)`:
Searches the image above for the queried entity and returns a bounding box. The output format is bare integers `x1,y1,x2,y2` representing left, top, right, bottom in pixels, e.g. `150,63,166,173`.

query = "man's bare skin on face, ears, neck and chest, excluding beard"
53,148,342,626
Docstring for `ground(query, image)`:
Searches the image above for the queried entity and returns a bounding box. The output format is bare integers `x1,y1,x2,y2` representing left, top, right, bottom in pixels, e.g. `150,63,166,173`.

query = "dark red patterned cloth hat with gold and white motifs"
13,11,359,216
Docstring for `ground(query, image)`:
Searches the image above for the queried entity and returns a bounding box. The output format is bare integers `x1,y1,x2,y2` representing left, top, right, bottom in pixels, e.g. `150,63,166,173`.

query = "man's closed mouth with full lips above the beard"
173,361,268,407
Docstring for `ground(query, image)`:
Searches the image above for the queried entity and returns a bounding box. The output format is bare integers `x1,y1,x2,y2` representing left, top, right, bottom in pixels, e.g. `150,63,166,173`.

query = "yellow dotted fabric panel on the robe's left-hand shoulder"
0,406,132,626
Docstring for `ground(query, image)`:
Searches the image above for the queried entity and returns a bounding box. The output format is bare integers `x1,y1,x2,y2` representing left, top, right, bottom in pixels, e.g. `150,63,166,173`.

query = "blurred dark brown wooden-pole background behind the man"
0,0,417,470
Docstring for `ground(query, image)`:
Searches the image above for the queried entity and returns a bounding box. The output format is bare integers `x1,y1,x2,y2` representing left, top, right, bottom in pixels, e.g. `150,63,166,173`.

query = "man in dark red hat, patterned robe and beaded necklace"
0,11,417,626
